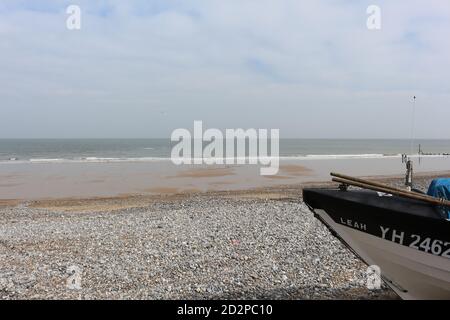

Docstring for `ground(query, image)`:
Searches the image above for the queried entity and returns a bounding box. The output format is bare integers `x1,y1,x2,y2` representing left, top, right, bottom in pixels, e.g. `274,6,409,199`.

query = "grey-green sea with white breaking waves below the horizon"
0,139,450,162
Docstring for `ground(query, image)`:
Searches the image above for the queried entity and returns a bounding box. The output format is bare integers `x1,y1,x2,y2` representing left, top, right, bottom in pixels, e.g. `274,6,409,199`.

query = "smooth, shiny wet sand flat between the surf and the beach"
0,157,450,200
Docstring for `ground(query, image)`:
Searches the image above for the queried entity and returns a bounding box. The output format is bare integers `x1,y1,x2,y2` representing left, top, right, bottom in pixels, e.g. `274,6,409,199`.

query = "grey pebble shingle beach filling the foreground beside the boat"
0,166,447,299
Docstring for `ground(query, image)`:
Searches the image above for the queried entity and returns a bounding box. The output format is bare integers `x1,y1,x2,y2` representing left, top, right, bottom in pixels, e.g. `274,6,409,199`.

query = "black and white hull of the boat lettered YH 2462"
305,191,450,299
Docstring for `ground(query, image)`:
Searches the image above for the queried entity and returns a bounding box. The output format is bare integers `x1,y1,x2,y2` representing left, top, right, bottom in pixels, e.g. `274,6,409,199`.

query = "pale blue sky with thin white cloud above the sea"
0,0,450,139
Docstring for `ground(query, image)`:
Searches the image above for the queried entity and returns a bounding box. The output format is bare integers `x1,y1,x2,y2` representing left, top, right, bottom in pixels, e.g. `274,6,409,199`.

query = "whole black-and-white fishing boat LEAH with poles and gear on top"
303,173,450,299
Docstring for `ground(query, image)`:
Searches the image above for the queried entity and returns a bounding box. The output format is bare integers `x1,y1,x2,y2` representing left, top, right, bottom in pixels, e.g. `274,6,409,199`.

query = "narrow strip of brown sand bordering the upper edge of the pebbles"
14,171,450,213
